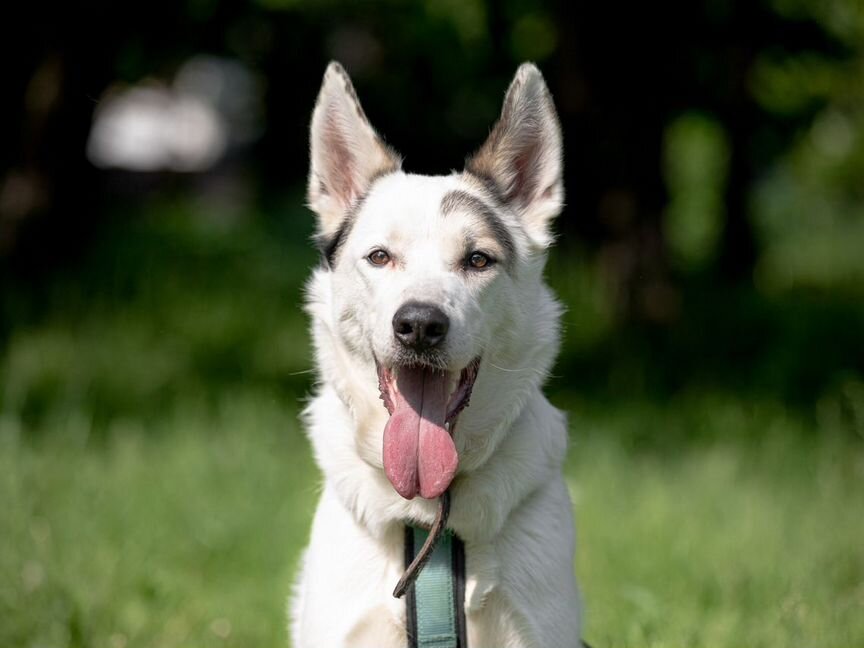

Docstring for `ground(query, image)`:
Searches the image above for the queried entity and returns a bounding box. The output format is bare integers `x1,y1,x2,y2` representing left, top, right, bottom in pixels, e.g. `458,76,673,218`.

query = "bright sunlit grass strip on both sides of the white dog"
0,393,864,648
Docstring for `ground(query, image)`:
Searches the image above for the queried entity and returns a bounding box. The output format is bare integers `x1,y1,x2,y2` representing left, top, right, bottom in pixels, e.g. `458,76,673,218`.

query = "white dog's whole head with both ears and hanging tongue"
308,63,563,498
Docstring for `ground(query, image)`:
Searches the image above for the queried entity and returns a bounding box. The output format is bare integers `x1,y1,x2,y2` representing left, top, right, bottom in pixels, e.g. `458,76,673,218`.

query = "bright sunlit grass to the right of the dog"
572,412,864,648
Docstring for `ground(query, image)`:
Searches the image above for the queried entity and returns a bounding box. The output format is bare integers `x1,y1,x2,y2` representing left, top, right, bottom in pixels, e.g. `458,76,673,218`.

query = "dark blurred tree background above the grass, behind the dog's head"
0,0,864,426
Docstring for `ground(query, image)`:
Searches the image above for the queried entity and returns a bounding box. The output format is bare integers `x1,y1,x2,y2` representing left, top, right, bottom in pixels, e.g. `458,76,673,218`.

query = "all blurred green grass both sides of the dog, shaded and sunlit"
0,200,864,648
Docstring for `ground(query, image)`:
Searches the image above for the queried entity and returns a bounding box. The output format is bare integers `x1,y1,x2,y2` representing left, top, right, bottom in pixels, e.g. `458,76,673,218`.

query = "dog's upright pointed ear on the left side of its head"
307,61,401,236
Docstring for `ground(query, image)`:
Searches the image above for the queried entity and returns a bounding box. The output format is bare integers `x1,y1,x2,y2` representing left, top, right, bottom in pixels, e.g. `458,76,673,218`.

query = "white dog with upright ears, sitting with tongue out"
289,62,581,648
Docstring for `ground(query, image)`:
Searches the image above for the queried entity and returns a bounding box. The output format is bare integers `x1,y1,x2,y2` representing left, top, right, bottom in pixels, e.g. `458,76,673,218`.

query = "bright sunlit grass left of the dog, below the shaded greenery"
0,394,317,648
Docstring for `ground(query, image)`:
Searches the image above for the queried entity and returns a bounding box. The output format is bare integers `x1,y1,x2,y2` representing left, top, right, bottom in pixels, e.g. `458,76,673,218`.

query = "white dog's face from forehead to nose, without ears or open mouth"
331,172,527,373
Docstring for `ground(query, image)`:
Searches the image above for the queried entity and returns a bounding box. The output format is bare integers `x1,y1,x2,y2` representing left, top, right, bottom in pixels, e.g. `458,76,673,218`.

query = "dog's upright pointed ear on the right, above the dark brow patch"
465,63,564,246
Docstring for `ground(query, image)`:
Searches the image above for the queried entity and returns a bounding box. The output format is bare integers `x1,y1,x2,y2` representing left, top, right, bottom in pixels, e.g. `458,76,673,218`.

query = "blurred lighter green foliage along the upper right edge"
751,0,864,298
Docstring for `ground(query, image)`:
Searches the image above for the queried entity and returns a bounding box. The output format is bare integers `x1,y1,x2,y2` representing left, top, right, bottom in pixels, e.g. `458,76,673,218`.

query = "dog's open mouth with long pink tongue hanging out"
377,357,480,499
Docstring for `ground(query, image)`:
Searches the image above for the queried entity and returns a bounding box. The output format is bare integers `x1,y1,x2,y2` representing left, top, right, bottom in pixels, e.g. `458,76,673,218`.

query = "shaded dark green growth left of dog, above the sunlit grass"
0,198,315,427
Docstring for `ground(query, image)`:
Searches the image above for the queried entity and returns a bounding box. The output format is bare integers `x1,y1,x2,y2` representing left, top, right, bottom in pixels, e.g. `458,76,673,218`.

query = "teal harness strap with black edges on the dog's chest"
405,526,468,648
